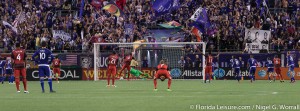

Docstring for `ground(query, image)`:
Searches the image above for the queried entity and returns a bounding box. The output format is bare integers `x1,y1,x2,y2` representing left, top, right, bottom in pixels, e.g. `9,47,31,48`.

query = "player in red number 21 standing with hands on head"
106,51,119,87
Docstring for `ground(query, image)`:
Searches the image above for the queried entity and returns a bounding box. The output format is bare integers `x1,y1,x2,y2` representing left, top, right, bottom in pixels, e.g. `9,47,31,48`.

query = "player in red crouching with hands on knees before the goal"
153,60,172,91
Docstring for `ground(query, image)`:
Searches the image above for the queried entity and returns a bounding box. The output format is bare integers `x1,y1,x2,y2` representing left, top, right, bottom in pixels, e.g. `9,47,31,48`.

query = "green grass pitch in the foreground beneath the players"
0,80,300,111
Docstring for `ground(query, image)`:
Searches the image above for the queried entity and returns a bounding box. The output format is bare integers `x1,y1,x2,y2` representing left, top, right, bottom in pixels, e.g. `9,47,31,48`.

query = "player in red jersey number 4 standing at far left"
11,43,29,93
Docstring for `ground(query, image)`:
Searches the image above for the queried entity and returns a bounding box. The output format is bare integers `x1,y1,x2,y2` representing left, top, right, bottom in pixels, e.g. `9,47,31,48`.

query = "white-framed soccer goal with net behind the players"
93,42,205,81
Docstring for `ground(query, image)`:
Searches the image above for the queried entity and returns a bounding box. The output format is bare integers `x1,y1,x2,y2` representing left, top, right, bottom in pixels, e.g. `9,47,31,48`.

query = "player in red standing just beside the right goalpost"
204,52,219,83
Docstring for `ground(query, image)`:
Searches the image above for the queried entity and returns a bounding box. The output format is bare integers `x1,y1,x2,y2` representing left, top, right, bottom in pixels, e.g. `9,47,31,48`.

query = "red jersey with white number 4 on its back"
11,49,27,68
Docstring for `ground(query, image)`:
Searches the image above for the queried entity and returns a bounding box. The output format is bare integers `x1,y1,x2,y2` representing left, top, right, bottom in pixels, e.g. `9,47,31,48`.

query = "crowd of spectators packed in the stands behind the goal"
0,0,300,51
